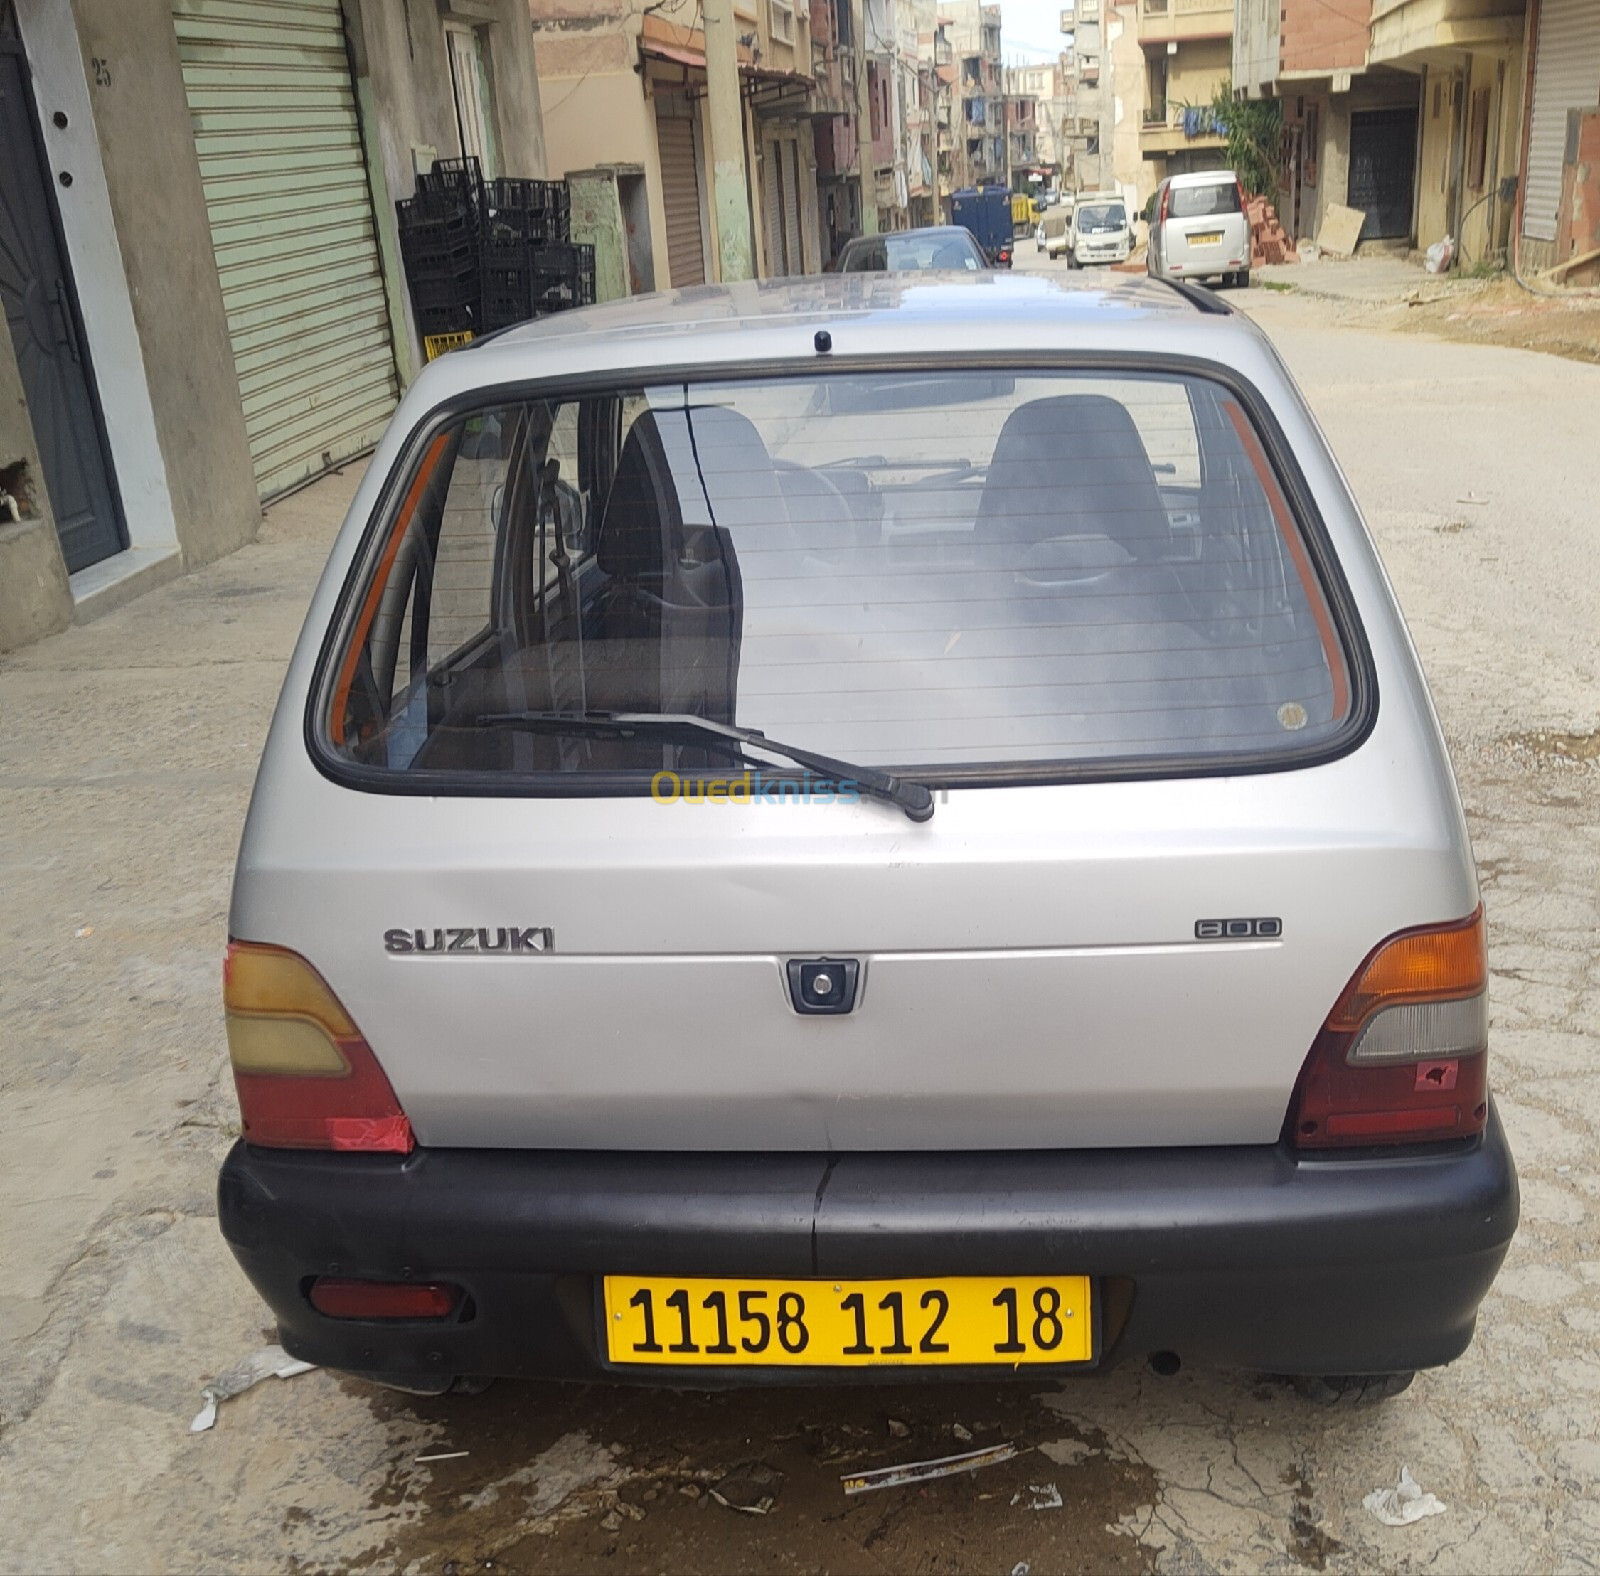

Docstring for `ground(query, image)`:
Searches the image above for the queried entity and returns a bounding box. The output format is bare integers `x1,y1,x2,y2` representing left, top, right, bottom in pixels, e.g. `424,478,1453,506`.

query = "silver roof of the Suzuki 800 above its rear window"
406,268,1270,396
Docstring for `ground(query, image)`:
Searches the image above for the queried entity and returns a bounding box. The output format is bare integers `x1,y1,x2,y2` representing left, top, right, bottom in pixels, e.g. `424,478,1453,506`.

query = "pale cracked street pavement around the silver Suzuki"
0,264,1600,1573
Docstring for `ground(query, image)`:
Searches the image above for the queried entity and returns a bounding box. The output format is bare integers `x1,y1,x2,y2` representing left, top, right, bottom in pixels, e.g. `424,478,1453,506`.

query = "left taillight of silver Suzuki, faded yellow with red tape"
222,941,416,1155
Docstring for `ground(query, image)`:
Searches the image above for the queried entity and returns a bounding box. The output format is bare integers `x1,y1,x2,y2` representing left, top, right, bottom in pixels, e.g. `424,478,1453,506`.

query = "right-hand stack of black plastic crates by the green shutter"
483,179,595,330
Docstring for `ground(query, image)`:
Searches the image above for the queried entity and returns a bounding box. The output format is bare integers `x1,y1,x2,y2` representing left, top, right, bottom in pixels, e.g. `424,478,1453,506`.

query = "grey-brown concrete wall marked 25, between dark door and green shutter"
72,0,261,566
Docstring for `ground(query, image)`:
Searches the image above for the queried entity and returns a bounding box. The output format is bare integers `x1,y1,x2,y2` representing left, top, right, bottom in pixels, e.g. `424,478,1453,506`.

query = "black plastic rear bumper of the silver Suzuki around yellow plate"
219,1110,1518,1387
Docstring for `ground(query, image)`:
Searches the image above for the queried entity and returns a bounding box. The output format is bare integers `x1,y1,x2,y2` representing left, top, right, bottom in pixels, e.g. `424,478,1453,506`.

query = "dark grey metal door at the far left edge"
0,13,128,573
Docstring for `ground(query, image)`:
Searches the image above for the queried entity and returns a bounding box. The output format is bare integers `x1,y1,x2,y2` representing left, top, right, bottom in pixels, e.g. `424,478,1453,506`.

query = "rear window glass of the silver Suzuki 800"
315,371,1352,792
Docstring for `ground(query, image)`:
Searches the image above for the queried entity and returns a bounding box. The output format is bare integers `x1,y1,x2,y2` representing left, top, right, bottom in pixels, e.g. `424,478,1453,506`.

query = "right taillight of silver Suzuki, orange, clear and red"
1286,907,1490,1149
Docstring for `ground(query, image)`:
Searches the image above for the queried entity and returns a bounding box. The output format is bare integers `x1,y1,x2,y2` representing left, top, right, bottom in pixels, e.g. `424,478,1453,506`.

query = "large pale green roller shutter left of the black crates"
173,0,398,499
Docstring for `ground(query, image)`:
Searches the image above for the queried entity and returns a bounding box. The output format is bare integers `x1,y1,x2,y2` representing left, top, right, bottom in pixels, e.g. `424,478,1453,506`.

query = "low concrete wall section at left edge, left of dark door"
0,328,72,651
